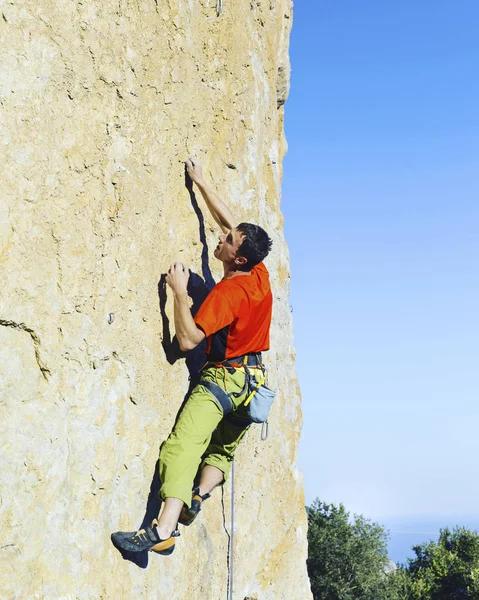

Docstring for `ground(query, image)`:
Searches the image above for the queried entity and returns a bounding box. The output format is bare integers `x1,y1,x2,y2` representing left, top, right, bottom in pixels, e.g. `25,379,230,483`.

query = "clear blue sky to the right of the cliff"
282,0,479,521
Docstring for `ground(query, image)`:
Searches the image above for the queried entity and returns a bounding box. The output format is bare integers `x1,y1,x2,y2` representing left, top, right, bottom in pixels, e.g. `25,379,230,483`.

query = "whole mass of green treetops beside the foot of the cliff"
308,500,479,600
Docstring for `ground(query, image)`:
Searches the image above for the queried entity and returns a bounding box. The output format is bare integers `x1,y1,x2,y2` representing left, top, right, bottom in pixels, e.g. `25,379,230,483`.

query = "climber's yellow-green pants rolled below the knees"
159,367,257,506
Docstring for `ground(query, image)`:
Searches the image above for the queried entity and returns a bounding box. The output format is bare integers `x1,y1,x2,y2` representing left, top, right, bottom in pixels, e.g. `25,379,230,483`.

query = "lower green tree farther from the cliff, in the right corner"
405,527,479,600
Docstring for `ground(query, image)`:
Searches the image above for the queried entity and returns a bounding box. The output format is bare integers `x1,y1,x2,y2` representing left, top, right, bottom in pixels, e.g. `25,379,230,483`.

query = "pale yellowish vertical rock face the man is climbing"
0,0,311,600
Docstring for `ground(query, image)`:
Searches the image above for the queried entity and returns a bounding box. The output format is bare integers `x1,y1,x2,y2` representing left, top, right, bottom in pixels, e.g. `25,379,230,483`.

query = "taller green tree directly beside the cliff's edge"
308,499,394,600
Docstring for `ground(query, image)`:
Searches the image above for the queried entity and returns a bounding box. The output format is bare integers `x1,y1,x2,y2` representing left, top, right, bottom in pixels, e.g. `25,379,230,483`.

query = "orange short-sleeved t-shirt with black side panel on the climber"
195,263,273,362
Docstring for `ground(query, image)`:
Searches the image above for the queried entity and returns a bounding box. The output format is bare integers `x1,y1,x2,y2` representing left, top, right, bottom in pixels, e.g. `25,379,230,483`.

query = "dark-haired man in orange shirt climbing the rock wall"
112,157,272,555
